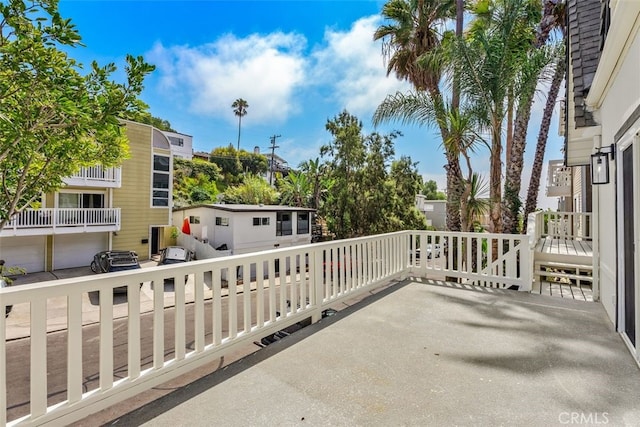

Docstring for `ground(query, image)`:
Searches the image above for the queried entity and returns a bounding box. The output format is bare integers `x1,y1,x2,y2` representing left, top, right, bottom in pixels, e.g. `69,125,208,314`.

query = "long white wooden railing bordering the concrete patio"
0,231,531,425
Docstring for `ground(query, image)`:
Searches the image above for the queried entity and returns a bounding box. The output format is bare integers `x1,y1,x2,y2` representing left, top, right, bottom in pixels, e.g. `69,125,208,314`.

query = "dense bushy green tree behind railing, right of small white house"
314,111,426,238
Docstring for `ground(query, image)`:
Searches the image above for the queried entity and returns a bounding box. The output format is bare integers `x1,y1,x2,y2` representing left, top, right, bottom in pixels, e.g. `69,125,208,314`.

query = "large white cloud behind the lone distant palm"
147,32,307,124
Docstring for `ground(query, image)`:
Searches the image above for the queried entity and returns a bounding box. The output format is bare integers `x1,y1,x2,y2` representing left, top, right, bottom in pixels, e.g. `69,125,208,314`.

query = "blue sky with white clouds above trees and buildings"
60,0,562,207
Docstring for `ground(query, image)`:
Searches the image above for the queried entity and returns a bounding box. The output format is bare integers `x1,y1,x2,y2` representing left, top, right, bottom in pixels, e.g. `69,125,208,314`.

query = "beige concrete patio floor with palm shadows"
106,279,640,426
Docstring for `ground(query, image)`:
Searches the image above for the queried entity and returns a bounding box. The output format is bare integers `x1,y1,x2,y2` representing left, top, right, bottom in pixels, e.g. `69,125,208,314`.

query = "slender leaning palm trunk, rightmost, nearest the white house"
523,55,566,221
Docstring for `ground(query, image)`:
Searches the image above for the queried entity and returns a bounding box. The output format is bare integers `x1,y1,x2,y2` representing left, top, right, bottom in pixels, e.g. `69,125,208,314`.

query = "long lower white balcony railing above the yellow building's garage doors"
0,208,120,237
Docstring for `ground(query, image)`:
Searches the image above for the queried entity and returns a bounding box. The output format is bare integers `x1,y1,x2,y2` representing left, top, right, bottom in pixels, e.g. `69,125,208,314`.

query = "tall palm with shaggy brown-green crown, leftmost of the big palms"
373,0,462,231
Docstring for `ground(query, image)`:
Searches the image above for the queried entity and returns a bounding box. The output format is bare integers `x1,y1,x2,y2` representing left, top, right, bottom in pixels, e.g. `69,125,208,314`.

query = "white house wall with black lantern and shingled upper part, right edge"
565,0,640,360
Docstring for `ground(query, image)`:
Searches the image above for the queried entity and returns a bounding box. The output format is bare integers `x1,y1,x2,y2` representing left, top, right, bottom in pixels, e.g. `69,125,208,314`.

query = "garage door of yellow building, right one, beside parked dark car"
53,233,108,270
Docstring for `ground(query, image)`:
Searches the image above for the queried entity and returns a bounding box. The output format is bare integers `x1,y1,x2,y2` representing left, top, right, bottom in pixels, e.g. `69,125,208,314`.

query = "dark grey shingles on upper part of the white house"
568,0,601,128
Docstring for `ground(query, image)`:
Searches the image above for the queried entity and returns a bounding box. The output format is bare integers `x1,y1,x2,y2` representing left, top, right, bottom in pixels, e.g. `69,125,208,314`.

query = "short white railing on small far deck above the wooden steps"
527,211,593,244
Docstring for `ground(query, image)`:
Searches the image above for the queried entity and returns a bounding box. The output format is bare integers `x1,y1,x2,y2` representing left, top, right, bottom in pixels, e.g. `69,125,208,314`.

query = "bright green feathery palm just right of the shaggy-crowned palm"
450,0,536,233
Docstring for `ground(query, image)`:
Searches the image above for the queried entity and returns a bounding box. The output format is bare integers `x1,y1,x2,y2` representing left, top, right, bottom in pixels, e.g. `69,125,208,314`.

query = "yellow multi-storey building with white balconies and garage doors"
0,121,173,272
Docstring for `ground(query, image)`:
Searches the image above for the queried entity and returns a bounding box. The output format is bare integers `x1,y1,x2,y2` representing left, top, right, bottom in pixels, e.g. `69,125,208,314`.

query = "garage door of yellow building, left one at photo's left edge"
0,236,46,273
